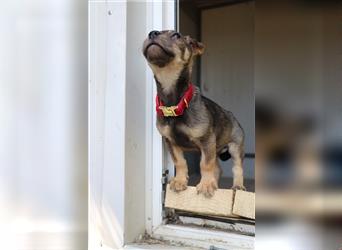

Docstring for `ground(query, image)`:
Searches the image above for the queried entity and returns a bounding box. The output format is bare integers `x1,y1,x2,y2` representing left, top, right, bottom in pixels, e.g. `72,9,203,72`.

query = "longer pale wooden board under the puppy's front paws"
165,185,233,216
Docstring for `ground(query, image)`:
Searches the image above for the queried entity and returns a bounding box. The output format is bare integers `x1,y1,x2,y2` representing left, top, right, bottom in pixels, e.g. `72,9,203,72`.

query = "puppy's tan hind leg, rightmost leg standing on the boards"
228,142,246,190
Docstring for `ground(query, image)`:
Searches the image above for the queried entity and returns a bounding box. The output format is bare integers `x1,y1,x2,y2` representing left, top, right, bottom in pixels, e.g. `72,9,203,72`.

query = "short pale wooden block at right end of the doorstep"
233,190,255,220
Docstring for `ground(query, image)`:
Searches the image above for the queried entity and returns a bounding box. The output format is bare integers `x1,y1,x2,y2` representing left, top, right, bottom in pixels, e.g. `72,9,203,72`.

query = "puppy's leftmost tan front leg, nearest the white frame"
166,139,189,192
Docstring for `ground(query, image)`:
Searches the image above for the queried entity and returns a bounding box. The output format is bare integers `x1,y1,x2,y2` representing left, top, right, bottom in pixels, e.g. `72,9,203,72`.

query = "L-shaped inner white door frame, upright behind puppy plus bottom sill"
146,1,254,249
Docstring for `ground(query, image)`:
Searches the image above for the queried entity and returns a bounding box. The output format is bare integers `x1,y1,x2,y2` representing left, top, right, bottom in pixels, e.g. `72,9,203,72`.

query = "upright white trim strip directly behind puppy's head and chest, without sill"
145,0,175,234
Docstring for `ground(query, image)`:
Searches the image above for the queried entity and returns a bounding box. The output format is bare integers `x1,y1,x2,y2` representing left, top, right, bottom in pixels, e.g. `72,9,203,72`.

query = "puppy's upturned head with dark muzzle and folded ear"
143,30,204,68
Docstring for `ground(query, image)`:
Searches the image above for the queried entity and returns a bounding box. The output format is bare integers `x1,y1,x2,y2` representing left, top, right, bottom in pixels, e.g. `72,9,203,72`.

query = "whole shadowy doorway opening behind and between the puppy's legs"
177,0,255,192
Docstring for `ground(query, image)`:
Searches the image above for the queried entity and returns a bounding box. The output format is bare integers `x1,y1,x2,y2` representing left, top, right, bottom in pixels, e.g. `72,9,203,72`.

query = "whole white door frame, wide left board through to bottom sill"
88,0,253,249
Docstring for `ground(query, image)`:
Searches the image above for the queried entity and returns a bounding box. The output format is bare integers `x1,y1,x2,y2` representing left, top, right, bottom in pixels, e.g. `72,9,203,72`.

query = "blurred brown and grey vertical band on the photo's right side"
254,0,342,250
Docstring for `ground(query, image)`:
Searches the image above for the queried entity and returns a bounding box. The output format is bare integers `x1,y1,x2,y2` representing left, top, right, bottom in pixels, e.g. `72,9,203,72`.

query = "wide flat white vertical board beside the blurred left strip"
89,1,127,247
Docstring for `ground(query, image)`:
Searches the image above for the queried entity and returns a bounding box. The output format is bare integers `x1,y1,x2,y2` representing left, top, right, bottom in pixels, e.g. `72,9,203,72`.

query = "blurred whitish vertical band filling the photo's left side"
0,0,88,250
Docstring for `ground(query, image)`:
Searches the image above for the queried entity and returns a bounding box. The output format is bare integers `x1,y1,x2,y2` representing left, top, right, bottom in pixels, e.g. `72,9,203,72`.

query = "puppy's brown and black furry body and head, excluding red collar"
143,31,244,197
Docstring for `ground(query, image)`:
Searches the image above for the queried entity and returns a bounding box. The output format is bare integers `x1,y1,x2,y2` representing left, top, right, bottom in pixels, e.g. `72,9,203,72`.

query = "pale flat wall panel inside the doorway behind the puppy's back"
201,2,255,179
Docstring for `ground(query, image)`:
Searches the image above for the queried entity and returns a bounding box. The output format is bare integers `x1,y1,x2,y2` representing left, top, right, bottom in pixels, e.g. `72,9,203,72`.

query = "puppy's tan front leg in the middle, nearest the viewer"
196,136,220,197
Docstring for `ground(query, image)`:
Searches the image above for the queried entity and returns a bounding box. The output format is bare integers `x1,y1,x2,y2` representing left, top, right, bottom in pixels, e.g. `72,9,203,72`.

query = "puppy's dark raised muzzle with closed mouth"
144,42,175,67
